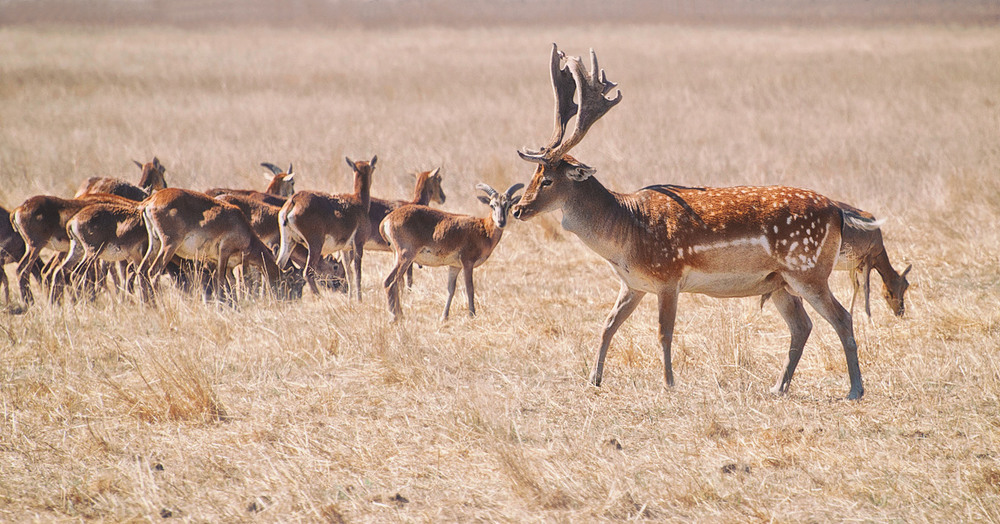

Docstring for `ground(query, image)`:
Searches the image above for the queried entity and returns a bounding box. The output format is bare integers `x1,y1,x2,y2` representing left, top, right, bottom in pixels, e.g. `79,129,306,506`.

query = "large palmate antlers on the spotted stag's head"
518,44,622,163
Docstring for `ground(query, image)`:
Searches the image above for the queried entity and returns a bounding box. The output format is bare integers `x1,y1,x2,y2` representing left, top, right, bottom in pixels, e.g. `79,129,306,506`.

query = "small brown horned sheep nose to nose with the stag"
379,184,524,322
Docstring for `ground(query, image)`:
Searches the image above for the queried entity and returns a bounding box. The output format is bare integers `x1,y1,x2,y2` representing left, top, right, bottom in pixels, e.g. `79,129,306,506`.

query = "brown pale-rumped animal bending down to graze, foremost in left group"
138,189,282,298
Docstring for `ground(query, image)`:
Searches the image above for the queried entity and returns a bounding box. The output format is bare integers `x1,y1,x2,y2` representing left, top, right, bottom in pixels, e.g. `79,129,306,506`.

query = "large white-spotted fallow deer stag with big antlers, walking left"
513,45,866,399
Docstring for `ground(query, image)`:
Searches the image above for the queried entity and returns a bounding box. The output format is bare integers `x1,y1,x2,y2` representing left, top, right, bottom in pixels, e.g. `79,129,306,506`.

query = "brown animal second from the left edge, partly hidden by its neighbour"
11,193,135,304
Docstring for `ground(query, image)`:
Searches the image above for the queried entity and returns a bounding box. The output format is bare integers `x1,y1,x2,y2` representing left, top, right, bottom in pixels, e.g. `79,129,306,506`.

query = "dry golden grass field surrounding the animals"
0,12,1000,523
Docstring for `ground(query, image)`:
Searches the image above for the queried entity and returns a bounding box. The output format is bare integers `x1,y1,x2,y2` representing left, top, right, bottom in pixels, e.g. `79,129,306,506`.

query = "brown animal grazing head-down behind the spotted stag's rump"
834,202,913,317
